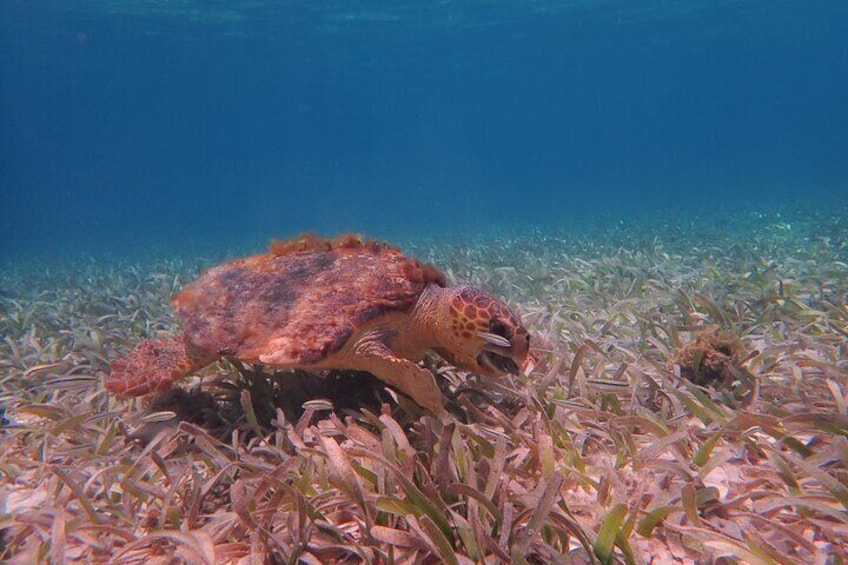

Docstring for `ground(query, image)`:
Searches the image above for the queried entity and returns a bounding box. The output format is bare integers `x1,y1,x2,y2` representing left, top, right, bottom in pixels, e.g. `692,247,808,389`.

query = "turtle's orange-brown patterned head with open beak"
434,286,530,377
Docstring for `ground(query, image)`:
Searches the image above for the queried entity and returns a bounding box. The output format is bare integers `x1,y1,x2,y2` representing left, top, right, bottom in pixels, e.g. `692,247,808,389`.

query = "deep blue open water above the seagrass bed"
0,0,848,257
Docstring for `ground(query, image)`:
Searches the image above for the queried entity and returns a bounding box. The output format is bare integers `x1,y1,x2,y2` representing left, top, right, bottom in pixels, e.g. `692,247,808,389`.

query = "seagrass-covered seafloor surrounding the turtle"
0,205,848,564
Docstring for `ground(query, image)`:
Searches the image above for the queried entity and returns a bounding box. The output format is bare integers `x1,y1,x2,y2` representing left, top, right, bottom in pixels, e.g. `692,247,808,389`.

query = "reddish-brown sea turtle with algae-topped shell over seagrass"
106,231,530,414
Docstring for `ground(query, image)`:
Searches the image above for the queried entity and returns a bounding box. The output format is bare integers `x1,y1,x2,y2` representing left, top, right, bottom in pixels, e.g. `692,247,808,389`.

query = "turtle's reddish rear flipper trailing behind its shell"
106,336,215,396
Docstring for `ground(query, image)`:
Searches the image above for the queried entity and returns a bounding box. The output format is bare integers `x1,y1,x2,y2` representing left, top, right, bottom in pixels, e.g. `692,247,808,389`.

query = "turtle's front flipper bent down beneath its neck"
354,335,445,416
